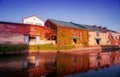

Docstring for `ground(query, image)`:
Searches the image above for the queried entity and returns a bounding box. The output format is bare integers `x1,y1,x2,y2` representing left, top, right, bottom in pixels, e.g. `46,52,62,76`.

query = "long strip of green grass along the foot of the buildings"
0,44,74,52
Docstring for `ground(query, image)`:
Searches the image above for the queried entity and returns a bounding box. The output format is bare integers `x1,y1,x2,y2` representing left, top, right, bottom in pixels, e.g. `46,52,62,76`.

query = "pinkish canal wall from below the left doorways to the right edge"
28,45,120,54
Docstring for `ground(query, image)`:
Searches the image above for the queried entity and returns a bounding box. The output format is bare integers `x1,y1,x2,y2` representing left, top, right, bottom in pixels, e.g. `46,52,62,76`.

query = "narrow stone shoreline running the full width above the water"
0,45,120,55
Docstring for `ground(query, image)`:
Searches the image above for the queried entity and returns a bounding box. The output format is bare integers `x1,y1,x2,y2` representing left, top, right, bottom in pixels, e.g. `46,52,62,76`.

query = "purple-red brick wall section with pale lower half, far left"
0,23,29,44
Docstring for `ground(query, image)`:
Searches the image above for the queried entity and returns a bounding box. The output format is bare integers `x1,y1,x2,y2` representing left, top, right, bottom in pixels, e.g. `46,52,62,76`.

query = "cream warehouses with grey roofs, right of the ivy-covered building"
72,24,120,46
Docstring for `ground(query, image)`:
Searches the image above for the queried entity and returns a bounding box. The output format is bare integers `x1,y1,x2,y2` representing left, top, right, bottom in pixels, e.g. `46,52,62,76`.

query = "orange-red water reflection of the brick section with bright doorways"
21,53,56,77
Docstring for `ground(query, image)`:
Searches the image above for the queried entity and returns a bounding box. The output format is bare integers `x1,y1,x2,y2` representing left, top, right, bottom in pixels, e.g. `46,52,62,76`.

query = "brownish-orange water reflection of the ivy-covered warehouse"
57,53,89,76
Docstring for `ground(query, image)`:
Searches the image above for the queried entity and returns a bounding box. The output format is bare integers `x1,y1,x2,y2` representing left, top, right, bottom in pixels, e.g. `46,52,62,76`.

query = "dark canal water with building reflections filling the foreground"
0,50,120,77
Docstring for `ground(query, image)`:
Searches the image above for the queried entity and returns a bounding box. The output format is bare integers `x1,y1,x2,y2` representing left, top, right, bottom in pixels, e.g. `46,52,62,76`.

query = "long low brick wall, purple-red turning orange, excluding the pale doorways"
0,22,51,43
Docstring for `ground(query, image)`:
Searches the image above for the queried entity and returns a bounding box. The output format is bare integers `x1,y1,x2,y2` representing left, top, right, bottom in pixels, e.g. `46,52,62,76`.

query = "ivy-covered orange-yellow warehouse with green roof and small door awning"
45,19,89,45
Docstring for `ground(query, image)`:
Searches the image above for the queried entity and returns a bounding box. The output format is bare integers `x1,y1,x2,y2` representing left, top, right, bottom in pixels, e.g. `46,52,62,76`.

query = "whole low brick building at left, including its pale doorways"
0,22,54,45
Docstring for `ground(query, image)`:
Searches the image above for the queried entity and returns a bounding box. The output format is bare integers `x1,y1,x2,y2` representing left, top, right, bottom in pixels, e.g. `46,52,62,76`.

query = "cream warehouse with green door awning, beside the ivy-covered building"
72,24,107,46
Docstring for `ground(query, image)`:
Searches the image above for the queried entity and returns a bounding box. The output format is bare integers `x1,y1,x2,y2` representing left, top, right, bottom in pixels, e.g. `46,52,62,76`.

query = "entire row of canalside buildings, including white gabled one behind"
0,16,120,46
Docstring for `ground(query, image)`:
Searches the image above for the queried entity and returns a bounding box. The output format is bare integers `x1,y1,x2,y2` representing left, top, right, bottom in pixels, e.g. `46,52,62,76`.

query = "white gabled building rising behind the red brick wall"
22,16,44,26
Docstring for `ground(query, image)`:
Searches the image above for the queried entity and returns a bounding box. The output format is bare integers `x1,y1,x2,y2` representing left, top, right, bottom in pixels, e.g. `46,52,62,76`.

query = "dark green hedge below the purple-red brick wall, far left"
0,44,28,52
